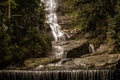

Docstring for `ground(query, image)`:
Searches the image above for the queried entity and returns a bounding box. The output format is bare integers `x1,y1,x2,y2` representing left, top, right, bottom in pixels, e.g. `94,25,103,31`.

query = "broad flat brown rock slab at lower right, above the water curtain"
63,54,120,69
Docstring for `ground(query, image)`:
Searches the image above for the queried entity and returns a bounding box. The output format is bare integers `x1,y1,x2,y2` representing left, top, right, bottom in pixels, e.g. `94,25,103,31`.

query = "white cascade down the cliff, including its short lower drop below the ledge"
41,0,64,59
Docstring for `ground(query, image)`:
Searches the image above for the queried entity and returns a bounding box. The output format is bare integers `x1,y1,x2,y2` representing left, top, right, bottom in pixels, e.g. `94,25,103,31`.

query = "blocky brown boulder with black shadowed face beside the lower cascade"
52,39,89,58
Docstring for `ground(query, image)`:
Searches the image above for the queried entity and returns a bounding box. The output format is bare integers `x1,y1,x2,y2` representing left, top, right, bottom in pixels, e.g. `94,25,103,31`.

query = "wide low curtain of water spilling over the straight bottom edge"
0,70,120,80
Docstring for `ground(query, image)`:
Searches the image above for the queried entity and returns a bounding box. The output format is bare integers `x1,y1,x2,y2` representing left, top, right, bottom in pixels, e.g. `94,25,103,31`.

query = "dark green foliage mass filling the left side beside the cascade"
0,0,51,66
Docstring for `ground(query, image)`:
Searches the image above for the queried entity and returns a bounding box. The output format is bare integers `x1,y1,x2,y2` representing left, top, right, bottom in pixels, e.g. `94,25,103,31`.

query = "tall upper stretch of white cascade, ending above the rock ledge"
42,0,63,41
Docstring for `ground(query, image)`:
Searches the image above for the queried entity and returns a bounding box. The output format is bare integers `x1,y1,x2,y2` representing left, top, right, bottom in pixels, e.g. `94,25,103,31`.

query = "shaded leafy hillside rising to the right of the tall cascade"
58,0,120,53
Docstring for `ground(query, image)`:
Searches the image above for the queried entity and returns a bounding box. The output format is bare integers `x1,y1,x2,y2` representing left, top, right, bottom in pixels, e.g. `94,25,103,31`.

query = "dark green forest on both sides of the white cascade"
0,0,120,67
